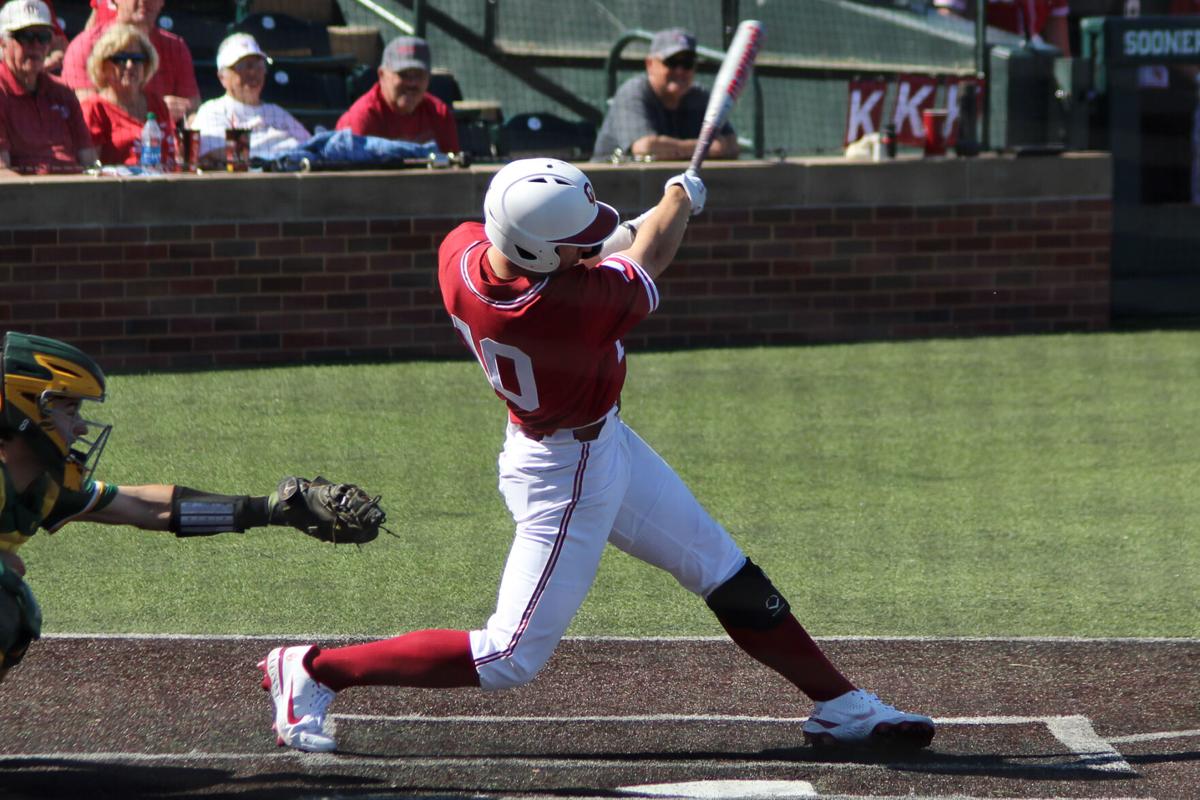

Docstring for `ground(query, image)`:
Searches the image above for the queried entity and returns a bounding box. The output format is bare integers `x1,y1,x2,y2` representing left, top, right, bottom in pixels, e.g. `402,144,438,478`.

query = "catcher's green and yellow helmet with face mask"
0,331,113,488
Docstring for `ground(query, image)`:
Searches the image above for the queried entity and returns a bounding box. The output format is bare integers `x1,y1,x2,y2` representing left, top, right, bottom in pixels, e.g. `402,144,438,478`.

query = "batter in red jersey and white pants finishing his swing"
260,158,934,751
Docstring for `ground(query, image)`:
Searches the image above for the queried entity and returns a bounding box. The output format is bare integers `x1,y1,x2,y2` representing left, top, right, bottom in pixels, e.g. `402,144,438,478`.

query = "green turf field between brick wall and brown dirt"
22,332,1200,637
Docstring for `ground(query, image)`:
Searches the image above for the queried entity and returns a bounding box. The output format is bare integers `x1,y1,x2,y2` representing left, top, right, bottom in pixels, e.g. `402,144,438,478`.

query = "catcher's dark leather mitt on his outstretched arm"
269,475,391,545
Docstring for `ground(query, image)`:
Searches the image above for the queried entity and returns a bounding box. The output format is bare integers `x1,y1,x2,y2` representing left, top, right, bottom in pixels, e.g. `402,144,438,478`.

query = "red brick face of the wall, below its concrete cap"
0,199,1111,369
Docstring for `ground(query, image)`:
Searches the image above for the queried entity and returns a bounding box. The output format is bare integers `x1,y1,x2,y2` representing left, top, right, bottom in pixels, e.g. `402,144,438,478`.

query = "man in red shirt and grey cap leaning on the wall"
337,36,458,152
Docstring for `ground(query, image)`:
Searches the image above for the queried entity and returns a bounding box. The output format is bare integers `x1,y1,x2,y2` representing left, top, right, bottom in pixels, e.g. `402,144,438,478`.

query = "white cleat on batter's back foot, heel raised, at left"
258,644,337,753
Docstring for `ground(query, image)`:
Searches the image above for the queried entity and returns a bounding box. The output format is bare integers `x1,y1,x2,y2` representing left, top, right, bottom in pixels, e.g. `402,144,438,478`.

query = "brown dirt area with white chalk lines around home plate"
0,637,1200,800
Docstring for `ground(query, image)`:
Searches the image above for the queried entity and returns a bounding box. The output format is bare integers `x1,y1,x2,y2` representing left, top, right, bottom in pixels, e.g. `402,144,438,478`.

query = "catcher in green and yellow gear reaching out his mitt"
0,332,385,681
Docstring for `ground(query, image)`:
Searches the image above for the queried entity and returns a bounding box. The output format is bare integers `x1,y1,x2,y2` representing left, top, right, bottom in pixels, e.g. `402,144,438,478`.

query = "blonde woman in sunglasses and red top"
83,24,175,164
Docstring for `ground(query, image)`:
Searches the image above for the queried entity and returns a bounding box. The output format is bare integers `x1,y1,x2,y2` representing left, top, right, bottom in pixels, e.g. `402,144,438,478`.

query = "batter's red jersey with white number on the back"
438,222,659,432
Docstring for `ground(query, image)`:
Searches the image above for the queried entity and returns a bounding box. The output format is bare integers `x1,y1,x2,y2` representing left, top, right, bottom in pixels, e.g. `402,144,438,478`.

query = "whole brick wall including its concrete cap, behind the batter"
0,161,1111,369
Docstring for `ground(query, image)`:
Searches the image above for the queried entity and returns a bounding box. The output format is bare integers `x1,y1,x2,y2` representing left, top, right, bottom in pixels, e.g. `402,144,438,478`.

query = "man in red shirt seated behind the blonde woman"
62,0,200,122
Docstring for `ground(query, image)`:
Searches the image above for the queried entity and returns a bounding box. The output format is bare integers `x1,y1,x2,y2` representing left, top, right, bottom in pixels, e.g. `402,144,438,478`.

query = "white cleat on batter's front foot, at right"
800,688,934,747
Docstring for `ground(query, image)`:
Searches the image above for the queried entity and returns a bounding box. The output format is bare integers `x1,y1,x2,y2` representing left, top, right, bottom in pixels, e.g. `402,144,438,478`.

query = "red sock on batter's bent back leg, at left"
305,631,479,692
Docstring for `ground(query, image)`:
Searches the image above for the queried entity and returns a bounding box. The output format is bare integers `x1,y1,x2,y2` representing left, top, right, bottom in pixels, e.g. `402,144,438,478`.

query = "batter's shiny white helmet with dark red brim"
484,158,620,272
